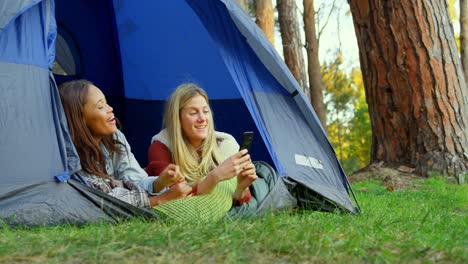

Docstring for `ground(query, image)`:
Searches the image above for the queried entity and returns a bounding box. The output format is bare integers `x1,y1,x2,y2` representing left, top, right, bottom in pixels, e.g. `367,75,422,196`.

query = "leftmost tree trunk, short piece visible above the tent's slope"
254,0,275,44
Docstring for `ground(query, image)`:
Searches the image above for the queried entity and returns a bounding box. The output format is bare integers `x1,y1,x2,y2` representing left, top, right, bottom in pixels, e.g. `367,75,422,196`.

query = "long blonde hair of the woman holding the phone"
163,83,221,182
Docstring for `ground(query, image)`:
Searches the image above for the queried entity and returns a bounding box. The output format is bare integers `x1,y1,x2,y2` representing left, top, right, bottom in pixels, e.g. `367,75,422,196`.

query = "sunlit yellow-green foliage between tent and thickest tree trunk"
322,54,372,174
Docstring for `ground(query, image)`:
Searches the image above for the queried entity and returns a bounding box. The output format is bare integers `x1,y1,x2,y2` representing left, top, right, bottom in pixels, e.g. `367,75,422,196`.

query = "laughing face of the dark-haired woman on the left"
82,85,117,141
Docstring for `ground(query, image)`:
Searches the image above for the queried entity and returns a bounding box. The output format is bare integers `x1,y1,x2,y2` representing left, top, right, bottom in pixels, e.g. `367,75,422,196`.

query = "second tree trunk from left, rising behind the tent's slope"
276,0,310,95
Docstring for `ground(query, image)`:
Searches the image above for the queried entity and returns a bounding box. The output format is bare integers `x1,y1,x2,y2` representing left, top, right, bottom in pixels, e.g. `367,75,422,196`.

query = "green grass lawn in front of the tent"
0,178,468,263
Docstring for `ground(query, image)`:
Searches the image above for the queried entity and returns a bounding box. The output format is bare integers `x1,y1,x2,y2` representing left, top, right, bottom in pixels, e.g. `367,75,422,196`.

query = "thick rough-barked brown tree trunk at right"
348,0,468,179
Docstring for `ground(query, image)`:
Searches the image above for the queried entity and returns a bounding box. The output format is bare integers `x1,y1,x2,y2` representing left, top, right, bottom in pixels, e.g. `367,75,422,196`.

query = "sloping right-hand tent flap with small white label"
188,0,356,212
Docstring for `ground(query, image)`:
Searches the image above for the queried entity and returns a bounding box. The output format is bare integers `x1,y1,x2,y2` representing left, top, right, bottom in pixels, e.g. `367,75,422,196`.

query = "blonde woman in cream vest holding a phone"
146,83,257,221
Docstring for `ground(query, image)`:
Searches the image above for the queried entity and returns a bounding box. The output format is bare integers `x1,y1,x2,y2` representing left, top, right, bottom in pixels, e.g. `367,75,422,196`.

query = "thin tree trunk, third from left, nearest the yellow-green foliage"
304,0,327,128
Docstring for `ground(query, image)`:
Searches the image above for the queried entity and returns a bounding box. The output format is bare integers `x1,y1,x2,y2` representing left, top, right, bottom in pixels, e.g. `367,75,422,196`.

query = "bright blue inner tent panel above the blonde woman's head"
114,0,240,100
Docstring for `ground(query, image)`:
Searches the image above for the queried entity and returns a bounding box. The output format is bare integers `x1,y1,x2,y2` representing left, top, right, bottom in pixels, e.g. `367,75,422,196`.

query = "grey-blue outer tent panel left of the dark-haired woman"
0,1,61,192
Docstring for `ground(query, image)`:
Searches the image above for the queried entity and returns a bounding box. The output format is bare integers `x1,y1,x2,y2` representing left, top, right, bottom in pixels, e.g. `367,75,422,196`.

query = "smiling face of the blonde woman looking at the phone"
180,95,211,148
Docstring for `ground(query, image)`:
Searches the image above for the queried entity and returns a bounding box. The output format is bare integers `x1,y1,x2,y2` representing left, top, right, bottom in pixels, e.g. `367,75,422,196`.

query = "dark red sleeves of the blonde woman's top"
145,141,252,206
